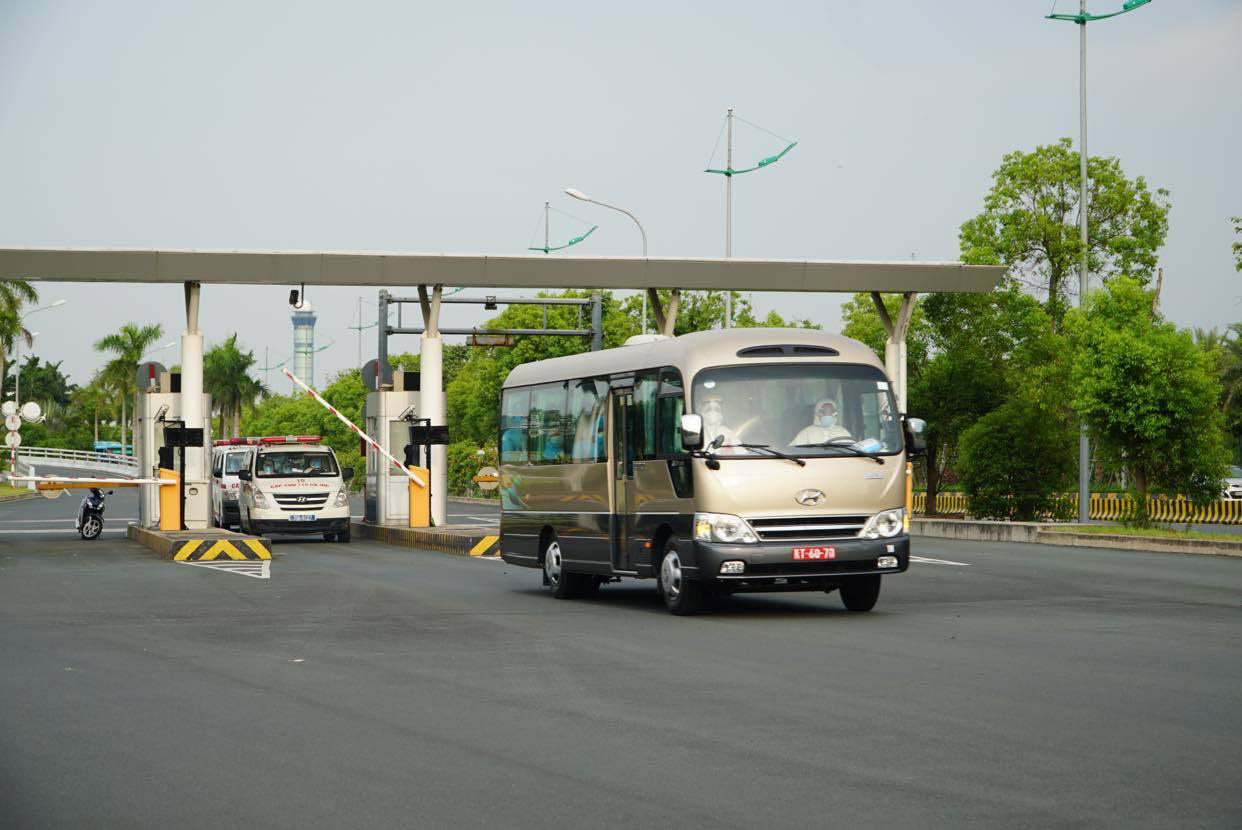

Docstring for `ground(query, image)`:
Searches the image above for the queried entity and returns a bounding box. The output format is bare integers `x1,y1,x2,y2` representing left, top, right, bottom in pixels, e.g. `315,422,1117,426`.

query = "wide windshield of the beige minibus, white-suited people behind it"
692,363,902,457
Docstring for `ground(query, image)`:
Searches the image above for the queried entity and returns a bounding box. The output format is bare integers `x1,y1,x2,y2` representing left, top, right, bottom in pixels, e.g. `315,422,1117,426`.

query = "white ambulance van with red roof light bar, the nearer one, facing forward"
237,435,354,542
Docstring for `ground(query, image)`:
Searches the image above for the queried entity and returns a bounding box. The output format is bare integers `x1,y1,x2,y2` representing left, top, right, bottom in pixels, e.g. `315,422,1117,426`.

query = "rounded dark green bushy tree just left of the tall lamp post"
956,393,1078,522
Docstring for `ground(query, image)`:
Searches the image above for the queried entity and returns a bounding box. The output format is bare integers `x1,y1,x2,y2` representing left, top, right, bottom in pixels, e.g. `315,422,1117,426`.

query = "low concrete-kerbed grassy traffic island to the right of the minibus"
910,517,1242,557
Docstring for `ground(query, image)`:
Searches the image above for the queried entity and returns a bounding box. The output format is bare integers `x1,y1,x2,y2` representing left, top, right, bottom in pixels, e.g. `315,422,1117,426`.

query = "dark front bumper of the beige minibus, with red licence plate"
682,533,910,591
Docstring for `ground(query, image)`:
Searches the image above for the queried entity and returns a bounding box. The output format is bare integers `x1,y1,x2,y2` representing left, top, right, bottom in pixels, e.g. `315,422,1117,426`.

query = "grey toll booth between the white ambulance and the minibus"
364,370,421,524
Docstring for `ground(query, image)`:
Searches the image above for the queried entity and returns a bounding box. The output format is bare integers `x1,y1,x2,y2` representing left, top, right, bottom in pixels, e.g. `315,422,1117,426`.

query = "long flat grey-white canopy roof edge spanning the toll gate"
0,247,1005,293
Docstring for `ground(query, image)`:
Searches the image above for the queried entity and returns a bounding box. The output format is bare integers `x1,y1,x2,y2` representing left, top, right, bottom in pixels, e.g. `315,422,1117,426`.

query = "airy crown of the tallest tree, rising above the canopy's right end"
960,138,1169,323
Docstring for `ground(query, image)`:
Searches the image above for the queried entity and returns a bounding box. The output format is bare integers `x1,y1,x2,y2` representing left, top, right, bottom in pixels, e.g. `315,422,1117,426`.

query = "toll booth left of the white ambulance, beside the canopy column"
134,372,211,531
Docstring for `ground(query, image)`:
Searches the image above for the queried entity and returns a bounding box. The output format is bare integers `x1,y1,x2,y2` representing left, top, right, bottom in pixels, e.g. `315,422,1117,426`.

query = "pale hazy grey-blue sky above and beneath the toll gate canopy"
0,0,1242,390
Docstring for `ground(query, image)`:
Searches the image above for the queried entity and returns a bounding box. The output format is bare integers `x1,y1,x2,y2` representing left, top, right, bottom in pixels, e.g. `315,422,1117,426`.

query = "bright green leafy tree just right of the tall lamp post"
1066,277,1228,526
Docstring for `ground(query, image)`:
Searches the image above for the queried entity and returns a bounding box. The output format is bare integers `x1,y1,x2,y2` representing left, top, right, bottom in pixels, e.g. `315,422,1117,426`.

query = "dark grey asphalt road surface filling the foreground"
0,491,1242,828
